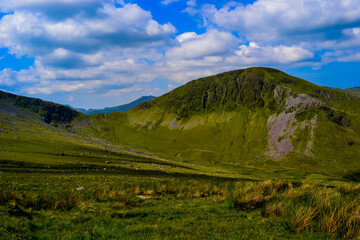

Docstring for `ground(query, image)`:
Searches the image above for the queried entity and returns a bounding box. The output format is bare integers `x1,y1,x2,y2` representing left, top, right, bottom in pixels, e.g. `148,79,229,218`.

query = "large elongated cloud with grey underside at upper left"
0,4,176,56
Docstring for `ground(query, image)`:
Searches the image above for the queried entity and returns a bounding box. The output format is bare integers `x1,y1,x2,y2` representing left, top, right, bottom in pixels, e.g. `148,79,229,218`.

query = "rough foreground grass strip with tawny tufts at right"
0,170,360,239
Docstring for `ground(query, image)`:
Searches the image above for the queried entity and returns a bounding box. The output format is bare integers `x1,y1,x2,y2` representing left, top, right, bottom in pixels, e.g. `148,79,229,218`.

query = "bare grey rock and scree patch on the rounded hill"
265,86,324,159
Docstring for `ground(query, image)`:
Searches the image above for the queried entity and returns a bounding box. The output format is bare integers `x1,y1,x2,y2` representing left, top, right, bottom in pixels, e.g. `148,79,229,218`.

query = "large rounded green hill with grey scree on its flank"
81,68,360,181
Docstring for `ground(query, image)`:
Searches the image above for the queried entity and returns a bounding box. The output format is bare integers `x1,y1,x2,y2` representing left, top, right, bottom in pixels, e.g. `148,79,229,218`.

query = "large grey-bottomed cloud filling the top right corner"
201,0,360,42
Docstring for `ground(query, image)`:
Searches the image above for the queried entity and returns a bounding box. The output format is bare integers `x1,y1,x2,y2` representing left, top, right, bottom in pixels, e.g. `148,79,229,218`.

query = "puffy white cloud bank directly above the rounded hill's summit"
154,29,314,83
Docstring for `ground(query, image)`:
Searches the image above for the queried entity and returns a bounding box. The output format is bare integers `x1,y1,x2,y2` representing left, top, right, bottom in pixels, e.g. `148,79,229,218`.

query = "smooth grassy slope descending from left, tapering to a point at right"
0,113,250,182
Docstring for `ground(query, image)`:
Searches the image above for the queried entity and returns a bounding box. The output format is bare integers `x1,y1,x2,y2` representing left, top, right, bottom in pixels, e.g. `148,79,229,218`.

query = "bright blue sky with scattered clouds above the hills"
0,0,360,108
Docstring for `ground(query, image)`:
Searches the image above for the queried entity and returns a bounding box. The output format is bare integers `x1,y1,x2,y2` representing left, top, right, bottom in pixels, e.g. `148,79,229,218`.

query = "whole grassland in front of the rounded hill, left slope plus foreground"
0,114,360,239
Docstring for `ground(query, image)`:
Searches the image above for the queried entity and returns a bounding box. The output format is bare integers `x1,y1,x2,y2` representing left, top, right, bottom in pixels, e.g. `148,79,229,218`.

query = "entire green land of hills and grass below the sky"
0,68,360,239
